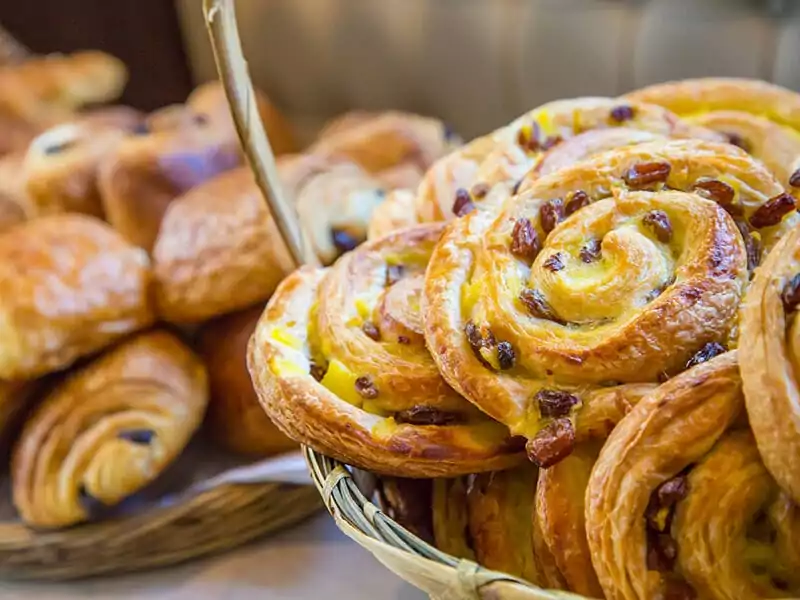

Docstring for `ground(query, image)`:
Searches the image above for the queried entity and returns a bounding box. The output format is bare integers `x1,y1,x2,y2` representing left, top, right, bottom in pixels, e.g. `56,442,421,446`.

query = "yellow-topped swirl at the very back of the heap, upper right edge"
626,78,800,188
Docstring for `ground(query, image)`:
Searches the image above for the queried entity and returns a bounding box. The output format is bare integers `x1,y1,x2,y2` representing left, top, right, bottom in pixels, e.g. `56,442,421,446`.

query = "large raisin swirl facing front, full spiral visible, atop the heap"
423,140,798,466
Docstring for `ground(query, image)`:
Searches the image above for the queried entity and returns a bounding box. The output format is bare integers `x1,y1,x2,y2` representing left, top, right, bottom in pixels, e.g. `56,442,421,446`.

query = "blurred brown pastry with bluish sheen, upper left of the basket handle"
98,102,242,251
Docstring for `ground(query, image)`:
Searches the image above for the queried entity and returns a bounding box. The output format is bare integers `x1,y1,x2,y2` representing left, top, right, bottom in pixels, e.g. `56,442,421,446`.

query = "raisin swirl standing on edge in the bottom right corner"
586,352,800,600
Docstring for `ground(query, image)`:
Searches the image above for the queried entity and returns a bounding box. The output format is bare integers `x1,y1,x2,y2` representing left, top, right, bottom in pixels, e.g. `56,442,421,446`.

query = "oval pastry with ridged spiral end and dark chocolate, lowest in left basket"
11,332,208,527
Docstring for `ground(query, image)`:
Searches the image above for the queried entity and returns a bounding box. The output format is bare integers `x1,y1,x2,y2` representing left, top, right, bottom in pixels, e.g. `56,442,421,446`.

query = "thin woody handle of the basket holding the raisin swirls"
203,0,319,268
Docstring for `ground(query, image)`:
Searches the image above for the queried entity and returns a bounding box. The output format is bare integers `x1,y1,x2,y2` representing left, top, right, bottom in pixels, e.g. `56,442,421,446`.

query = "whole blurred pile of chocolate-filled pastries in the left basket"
0,53,455,528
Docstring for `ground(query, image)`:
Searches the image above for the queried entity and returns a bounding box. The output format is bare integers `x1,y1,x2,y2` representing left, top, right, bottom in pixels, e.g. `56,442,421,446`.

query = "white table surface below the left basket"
0,512,427,600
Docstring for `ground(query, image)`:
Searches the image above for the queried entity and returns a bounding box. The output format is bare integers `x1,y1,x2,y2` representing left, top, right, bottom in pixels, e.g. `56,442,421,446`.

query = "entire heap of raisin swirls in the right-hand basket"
248,79,800,600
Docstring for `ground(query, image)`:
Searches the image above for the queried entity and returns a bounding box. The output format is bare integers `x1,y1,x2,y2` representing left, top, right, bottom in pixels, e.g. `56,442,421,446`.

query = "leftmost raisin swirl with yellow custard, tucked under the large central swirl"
248,225,521,477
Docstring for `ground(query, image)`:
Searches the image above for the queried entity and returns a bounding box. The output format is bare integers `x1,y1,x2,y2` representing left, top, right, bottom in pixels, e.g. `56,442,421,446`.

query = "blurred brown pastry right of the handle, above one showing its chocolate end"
308,111,458,173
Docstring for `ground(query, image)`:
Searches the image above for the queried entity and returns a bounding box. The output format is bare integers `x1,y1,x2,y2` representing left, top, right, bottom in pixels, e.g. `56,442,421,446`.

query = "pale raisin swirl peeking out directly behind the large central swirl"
416,98,722,222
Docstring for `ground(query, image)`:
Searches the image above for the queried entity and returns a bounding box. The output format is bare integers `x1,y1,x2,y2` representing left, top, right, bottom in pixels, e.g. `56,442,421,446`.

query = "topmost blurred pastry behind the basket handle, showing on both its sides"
186,81,297,156
